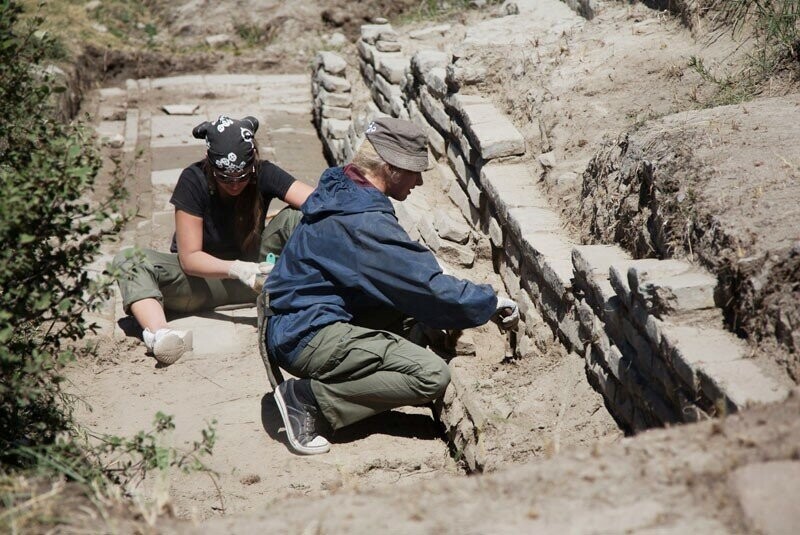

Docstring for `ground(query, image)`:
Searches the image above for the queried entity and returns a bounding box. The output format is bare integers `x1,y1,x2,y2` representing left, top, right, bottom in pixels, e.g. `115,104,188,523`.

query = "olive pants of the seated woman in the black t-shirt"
113,208,302,314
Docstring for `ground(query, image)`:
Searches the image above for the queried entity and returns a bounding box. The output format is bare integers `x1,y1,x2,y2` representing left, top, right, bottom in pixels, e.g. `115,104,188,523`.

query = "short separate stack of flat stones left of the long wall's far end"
311,52,353,164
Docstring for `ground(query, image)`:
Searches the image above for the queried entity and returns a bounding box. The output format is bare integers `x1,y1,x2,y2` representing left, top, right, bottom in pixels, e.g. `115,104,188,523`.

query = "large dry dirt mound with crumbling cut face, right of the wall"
576,96,800,381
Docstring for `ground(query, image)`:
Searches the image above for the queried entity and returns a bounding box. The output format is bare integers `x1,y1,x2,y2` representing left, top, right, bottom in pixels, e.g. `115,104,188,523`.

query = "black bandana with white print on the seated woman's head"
192,115,258,173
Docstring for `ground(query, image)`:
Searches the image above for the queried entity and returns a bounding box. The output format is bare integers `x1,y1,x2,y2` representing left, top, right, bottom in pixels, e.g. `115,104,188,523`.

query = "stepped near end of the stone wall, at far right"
572,245,788,431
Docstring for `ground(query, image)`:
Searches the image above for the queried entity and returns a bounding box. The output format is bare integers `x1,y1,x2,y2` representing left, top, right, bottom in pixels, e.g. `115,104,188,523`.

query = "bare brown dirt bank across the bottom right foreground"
184,391,800,533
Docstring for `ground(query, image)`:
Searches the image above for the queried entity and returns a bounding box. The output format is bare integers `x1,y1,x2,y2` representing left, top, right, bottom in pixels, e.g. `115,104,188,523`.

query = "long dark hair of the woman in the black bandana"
203,140,264,258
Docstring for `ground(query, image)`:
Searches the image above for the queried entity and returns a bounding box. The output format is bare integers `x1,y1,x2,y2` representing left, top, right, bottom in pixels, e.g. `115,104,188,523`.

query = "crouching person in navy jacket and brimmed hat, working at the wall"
266,118,519,455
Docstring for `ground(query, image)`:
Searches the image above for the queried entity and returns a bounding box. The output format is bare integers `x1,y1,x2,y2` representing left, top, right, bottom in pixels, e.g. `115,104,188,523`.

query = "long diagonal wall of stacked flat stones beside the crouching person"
310,25,788,444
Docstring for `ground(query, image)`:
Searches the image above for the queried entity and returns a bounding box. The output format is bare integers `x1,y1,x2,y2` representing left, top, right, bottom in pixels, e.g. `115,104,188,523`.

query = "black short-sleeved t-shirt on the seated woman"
169,161,295,260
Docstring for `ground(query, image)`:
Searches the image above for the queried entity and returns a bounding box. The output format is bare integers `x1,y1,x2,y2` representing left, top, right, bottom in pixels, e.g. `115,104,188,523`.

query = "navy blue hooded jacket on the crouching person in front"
266,167,497,363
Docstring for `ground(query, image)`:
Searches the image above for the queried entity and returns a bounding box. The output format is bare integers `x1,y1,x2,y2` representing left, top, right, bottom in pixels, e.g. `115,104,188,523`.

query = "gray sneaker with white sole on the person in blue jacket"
275,379,331,455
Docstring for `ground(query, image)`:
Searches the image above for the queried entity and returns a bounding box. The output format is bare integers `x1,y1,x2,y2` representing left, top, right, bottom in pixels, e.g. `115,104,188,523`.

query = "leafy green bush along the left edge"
0,0,122,464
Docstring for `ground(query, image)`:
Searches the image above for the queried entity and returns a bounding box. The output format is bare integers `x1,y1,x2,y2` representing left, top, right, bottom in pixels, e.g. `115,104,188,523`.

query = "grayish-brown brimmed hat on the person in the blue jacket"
364,117,431,173
